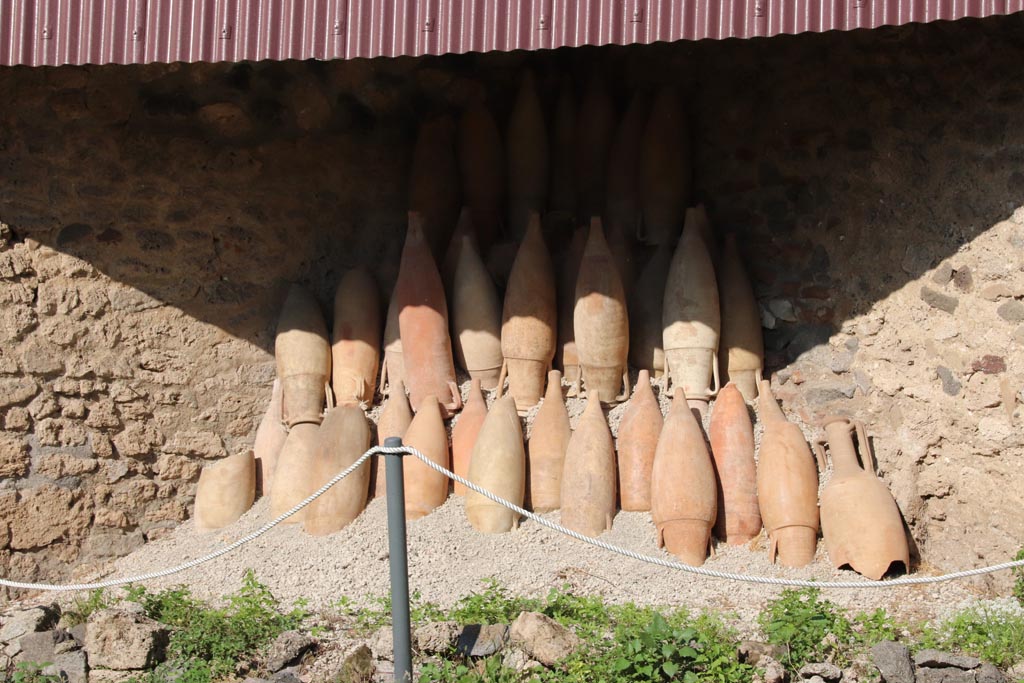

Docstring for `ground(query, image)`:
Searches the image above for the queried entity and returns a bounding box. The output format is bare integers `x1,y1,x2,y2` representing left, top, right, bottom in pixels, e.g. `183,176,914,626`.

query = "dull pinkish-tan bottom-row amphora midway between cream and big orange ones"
561,398,615,537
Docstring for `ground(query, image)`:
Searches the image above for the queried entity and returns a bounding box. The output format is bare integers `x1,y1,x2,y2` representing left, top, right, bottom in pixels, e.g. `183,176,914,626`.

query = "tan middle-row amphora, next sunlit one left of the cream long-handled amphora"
572,218,630,403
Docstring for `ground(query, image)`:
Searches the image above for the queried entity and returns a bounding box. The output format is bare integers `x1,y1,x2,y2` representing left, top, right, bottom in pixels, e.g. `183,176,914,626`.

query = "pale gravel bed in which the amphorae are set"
72,376,977,626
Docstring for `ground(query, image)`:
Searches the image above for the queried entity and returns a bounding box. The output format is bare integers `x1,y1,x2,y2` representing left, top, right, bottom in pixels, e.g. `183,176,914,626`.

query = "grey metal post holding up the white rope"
384,436,413,683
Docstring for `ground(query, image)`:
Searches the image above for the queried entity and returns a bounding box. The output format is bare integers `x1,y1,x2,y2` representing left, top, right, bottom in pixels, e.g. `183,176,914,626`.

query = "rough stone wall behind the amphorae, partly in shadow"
0,16,1024,579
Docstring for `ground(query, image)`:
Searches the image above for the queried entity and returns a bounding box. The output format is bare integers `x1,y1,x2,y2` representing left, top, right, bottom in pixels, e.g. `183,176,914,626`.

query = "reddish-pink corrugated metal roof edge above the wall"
0,0,1024,66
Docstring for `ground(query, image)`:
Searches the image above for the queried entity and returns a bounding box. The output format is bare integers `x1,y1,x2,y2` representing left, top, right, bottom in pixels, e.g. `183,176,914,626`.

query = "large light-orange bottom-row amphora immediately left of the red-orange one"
650,387,718,566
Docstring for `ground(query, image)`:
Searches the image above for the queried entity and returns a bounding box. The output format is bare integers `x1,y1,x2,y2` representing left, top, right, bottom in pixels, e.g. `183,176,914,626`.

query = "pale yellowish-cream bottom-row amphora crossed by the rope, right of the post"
466,396,526,533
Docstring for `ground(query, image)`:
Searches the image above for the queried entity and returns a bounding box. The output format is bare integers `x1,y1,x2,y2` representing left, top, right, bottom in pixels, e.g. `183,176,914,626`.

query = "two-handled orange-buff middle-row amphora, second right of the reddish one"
498,213,557,415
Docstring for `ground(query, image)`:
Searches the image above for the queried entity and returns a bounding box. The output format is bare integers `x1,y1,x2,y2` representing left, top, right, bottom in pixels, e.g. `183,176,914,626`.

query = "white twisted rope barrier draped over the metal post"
0,445,1024,591
